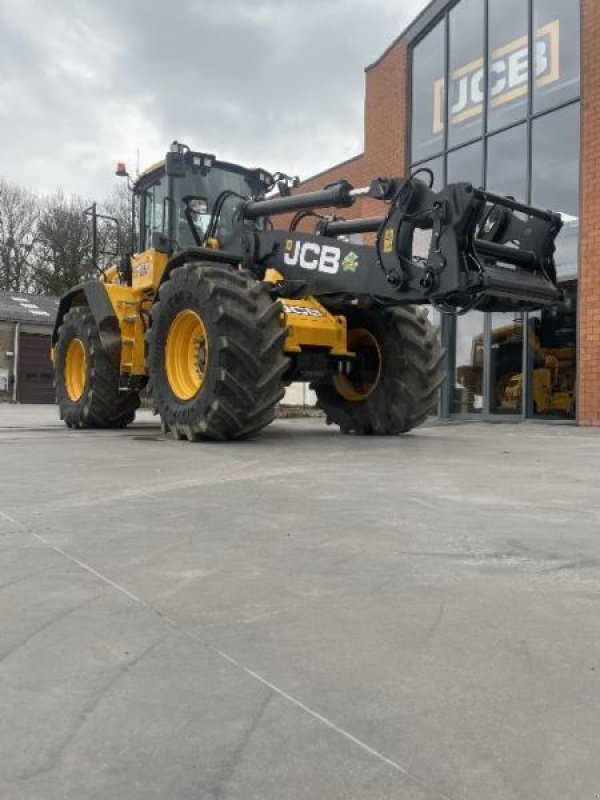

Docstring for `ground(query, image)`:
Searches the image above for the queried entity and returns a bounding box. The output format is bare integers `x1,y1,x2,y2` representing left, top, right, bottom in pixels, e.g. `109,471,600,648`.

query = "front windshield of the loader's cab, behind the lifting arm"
174,166,261,247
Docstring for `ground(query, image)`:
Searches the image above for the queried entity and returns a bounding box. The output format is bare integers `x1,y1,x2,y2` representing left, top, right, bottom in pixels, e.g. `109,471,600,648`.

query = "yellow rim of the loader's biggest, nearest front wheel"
165,308,208,400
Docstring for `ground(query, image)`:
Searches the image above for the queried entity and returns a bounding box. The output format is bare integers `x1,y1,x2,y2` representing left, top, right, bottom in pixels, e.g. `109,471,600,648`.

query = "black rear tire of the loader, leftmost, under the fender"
54,306,140,428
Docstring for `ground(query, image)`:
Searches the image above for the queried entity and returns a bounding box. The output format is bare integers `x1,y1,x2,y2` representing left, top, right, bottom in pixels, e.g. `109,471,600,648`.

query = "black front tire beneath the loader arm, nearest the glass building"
311,306,445,436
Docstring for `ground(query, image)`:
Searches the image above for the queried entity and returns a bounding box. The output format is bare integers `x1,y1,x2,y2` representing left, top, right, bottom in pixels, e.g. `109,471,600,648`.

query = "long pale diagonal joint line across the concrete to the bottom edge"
0,511,453,800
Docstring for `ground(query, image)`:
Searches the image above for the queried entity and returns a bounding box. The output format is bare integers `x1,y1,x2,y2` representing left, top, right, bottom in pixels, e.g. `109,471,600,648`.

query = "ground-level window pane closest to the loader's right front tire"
451,311,485,414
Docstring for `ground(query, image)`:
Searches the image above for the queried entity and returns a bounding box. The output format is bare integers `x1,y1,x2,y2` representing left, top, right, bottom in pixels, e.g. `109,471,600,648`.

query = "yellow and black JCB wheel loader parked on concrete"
52,142,562,441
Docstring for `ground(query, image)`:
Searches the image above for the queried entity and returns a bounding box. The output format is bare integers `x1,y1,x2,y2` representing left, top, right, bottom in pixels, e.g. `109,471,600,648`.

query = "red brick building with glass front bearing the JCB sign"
303,0,600,425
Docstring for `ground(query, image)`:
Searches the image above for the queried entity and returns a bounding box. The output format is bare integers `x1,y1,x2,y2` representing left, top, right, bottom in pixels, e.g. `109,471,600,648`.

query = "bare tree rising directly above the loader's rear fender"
35,191,95,294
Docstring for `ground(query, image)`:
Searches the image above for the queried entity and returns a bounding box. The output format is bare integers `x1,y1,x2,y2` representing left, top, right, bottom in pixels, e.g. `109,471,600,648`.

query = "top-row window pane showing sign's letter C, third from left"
488,0,529,130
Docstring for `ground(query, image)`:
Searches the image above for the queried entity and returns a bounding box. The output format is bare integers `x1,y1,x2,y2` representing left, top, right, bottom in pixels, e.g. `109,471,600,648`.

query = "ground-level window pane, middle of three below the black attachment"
490,312,523,414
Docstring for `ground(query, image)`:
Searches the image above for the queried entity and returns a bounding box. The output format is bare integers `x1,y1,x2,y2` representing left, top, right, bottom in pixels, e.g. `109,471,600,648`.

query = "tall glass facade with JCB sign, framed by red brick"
410,0,580,420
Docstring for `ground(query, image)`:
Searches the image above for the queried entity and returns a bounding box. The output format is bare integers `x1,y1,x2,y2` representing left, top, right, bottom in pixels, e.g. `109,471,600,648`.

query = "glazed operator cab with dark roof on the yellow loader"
134,142,273,252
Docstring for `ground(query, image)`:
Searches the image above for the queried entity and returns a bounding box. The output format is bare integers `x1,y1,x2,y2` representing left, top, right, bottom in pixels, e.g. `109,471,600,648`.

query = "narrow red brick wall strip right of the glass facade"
578,0,600,425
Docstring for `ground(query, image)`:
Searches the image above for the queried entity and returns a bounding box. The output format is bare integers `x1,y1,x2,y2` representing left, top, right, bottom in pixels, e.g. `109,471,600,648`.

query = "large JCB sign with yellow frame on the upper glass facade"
433,20,560,133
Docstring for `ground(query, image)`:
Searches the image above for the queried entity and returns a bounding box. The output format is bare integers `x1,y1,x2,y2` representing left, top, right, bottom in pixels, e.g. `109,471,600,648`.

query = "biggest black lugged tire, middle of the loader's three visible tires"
147,262,289,441
